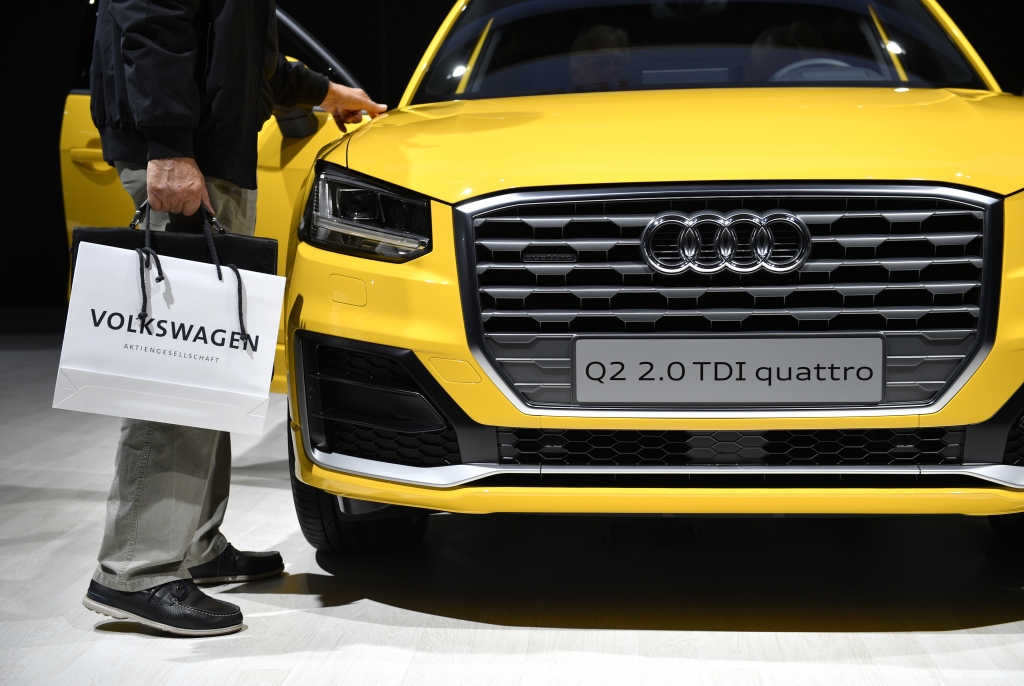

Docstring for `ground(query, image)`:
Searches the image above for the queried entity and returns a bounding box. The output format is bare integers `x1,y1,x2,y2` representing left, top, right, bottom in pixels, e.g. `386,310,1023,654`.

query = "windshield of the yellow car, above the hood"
413,0,985,104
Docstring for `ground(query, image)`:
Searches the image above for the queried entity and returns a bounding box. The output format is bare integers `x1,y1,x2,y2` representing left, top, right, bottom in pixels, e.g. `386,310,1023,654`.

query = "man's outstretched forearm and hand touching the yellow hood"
270,54,387,131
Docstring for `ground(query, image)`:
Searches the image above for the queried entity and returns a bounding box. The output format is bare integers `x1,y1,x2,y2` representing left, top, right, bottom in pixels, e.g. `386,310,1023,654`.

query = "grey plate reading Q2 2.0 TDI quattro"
573,337,886,404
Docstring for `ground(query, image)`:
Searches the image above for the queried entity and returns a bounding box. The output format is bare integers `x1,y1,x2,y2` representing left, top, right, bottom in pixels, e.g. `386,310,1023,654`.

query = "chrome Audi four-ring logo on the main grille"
640,210,811,274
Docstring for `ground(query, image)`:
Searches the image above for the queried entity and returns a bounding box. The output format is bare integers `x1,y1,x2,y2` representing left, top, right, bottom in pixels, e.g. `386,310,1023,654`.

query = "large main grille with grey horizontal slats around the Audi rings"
471,191,986,406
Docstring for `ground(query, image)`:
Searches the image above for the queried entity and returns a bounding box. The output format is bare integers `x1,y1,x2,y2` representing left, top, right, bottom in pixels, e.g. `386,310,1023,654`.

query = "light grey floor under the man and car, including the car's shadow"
0,336,1024,686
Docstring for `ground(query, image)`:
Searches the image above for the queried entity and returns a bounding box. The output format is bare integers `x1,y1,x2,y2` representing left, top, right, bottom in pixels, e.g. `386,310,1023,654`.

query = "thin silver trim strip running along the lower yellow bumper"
293,434,1024,488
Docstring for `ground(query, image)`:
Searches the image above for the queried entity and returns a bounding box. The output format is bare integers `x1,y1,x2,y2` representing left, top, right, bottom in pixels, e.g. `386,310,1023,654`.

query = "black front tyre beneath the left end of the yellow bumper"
288,430,428,553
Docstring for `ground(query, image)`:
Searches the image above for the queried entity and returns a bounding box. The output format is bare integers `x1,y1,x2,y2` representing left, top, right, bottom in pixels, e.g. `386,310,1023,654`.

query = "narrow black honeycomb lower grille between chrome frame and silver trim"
498,427,965,467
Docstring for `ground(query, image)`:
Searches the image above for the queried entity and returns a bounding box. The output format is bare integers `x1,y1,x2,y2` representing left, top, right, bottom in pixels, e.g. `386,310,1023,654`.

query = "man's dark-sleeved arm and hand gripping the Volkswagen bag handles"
110,0,211,215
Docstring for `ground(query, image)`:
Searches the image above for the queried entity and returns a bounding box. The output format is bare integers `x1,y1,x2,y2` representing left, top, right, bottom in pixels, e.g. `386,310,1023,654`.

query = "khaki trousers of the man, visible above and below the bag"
92,162,256,591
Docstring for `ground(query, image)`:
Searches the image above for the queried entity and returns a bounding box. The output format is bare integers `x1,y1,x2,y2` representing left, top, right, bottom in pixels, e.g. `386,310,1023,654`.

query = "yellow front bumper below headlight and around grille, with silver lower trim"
286,196,1024,514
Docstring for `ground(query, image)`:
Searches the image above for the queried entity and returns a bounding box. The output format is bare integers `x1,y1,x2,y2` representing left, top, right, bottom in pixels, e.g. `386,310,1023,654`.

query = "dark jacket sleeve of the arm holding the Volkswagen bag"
110,0,200,160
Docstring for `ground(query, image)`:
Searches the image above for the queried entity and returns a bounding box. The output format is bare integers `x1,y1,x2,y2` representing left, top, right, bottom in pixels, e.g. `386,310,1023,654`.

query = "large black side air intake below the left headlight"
303,341,461,467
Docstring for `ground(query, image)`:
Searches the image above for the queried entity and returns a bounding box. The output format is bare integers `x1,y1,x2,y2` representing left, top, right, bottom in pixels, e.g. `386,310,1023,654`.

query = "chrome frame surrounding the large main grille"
454,183,1002,419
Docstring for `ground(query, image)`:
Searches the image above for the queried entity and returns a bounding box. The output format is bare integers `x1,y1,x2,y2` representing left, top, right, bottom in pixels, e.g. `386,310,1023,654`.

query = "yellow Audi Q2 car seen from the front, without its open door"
285,0,1024,550
